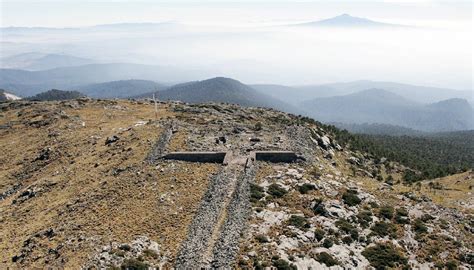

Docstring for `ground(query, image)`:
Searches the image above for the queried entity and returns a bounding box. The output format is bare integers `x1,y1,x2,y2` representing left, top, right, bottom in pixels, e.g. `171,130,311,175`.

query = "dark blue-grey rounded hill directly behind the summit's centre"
142,77,298,112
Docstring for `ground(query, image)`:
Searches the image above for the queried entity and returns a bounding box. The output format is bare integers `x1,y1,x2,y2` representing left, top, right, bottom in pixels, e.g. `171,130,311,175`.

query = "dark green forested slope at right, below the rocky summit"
320,122,474,183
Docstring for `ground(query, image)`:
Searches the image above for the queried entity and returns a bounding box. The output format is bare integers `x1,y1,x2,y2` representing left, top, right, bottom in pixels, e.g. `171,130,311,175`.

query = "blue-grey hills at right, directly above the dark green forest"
302,89,473,131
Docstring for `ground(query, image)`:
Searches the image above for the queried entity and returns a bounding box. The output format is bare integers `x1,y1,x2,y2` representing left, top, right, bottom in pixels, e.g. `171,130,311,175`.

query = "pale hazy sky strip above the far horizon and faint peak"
0,0,472,27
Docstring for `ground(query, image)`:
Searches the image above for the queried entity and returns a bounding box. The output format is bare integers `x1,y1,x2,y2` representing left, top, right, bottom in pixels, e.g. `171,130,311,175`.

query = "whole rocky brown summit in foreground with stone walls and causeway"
0,98,474,269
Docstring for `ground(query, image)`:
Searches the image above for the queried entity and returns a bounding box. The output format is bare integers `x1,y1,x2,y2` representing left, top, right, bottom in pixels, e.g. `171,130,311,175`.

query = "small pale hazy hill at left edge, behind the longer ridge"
0,52,94,71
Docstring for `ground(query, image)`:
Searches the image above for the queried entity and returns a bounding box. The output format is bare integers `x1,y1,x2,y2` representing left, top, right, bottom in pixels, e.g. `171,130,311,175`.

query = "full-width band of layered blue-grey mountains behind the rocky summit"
0,60,474,132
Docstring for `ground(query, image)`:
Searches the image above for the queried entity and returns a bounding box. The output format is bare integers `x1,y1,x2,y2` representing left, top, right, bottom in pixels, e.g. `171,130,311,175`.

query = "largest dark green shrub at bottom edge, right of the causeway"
362,243,408,269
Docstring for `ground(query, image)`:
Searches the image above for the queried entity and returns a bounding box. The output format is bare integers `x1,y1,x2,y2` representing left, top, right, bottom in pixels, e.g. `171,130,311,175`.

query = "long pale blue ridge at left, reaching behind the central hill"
0,63,204,96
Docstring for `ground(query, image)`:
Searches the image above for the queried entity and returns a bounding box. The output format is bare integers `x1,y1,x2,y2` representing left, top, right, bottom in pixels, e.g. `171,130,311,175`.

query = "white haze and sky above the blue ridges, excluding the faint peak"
0,0,473,89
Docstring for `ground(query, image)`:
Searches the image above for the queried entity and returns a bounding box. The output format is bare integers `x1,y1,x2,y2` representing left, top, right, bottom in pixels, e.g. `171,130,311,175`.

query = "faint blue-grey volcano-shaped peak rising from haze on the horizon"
299,14,402,27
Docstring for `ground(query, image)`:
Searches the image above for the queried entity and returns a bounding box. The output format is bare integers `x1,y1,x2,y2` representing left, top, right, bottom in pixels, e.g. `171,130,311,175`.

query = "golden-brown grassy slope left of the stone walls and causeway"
0,101,217,269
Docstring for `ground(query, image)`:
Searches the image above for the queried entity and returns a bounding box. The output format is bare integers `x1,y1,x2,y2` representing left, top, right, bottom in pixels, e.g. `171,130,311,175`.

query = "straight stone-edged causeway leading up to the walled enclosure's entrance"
176,159,255,269
